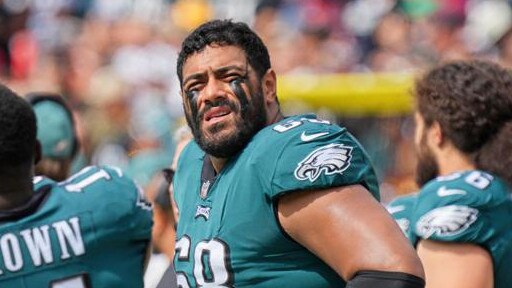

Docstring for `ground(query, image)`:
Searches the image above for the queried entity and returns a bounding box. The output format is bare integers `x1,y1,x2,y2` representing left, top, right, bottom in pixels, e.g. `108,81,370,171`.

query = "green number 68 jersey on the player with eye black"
174,115,379,287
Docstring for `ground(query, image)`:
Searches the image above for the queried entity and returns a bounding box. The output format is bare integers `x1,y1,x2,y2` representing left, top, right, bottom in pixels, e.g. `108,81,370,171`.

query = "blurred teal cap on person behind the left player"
33,101,75,159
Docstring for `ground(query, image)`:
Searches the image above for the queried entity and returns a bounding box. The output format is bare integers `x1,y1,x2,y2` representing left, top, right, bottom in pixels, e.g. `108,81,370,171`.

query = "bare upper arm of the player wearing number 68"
278,185,424,281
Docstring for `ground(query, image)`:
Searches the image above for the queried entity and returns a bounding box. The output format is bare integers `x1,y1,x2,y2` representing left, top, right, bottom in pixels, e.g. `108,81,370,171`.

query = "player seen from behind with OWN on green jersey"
0,85,152,288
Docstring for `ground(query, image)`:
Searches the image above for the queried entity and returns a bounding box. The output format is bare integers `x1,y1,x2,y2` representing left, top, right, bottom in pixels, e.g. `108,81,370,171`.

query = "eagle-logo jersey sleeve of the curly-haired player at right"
412,171,500,244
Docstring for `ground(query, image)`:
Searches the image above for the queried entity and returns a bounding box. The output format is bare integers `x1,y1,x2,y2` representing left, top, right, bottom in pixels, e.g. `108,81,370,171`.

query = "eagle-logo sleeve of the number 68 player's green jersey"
270,119,379,199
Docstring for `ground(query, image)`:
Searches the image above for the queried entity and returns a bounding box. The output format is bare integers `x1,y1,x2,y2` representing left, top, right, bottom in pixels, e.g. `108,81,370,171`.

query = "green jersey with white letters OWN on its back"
0,166,152,288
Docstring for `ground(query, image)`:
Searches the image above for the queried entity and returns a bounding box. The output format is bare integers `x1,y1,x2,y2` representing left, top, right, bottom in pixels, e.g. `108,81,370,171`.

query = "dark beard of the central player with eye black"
185,89,267,158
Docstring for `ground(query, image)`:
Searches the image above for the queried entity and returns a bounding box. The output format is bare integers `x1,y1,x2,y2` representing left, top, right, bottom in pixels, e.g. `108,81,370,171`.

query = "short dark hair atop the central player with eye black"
177,20,270,85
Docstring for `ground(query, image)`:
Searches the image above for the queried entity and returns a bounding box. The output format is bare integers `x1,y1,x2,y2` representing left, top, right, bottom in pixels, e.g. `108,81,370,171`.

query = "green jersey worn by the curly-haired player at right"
411,170,512,288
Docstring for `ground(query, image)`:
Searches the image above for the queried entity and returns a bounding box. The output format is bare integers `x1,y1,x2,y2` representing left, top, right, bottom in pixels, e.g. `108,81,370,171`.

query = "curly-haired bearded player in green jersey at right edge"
411,61,512,288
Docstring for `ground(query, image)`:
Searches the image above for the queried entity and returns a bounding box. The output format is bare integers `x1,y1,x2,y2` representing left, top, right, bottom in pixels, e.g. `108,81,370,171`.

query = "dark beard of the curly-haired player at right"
415,135,439,187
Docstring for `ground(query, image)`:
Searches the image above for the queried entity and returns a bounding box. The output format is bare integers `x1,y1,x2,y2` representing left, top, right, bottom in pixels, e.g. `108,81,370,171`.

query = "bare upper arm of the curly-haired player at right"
418,240,494,288
